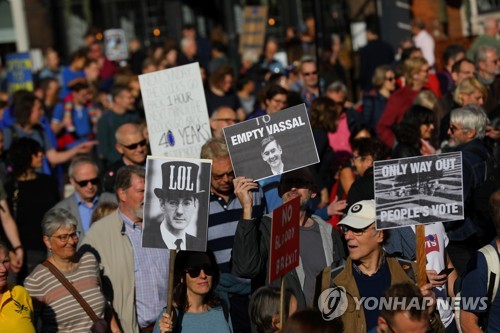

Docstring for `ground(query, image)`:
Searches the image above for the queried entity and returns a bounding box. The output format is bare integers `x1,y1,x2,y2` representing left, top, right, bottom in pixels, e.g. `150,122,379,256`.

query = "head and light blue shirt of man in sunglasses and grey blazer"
54,155,116,239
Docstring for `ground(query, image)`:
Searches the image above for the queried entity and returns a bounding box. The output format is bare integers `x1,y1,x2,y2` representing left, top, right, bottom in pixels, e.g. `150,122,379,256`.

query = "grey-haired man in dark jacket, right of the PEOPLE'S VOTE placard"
445,104,494,275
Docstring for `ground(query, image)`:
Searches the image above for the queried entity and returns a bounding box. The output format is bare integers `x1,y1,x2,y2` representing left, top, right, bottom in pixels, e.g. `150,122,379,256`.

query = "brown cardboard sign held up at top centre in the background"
239,6,267,56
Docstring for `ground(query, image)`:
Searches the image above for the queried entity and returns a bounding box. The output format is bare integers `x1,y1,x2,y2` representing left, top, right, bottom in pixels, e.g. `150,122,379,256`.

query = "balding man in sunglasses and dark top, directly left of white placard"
103,123,148,193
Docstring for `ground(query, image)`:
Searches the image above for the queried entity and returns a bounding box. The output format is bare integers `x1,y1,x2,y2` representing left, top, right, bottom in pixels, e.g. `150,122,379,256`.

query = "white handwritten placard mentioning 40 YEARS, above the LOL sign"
139,63,212,158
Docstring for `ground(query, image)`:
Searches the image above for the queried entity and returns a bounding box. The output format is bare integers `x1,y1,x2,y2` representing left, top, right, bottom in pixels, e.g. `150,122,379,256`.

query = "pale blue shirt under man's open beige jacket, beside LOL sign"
118,210,170,327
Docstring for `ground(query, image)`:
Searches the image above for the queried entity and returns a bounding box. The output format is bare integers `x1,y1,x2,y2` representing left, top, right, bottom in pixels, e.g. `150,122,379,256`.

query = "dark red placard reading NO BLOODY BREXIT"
269,197,300,283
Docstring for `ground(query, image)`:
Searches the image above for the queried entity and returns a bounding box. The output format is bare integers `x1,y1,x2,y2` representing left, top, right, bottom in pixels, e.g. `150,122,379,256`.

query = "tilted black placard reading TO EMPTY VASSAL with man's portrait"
223,104,319,180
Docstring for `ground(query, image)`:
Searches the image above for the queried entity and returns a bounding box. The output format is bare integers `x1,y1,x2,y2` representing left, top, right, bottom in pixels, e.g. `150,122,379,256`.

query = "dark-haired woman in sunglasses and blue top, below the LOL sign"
153,251,232,333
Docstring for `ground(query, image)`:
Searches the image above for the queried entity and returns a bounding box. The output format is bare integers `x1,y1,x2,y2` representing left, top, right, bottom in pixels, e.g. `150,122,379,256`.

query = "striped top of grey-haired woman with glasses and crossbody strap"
24,252,106,333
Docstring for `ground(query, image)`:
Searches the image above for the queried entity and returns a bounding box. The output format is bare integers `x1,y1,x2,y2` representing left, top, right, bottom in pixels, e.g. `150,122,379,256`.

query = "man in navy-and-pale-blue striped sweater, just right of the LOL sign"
201,139,265,332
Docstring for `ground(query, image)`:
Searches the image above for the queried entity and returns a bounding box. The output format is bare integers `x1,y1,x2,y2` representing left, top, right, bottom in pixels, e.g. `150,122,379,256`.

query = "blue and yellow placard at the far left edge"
5,52,33,95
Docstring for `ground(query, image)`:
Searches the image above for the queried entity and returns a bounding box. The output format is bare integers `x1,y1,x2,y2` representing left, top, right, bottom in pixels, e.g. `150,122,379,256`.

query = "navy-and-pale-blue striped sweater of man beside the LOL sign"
207,188,266,273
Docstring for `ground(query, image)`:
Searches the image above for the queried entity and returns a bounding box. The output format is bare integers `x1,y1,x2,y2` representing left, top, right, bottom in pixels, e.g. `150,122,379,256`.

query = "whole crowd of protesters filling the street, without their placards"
0,14,500,333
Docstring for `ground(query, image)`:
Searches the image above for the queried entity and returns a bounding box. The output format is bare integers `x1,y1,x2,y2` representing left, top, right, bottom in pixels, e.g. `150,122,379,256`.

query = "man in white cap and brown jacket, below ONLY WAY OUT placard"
322,200,442,333
